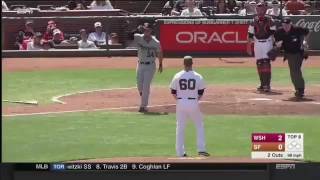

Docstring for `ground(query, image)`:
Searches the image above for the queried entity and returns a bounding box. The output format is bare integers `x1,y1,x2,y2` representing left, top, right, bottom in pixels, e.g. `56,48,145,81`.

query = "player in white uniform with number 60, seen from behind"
170,56,210,157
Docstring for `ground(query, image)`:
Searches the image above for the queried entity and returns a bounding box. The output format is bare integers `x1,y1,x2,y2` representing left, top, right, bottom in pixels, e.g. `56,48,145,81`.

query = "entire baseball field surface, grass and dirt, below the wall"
2,56,320,162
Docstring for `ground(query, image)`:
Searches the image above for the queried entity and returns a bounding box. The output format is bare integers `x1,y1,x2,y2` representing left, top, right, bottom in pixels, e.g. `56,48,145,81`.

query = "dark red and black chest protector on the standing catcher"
253,16,272,39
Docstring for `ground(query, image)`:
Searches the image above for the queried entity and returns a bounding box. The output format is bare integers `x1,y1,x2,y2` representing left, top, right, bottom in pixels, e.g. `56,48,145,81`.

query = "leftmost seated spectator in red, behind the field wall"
16,20,35,50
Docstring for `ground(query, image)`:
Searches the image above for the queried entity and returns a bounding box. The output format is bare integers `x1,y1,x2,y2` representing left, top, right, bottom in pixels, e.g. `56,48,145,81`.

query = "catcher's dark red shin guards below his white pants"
257,59,271,89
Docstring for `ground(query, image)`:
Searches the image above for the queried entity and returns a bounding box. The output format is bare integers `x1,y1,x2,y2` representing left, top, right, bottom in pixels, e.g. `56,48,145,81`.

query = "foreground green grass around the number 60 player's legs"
2,112,320,162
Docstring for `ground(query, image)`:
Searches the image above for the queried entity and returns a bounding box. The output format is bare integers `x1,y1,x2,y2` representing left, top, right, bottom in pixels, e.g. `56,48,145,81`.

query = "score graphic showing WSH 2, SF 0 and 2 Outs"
251,133,304,160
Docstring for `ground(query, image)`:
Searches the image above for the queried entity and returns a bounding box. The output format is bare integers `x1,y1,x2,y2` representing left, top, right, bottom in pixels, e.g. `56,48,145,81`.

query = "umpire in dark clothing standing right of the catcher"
275,17,309,99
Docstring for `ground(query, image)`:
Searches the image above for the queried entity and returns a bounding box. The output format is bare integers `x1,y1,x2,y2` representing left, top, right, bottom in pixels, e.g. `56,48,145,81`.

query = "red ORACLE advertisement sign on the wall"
160,24,248,53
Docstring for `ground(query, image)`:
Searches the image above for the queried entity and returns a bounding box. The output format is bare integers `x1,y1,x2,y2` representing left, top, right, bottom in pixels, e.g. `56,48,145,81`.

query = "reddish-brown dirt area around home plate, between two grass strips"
3,85,320,116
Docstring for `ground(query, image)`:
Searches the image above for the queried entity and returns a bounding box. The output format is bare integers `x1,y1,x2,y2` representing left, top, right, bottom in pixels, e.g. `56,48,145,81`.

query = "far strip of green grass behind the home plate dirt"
2,67,320,104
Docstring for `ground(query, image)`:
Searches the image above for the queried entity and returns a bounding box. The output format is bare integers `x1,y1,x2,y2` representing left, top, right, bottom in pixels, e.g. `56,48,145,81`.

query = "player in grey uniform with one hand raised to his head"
134,23,163,112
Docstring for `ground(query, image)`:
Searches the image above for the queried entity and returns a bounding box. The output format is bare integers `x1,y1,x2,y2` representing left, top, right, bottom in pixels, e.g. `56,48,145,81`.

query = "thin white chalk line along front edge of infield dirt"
2,101,214,117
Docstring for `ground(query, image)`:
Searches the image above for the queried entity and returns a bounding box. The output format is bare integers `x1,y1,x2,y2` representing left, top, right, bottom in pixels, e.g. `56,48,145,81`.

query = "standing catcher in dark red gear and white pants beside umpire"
247,2,276,92
